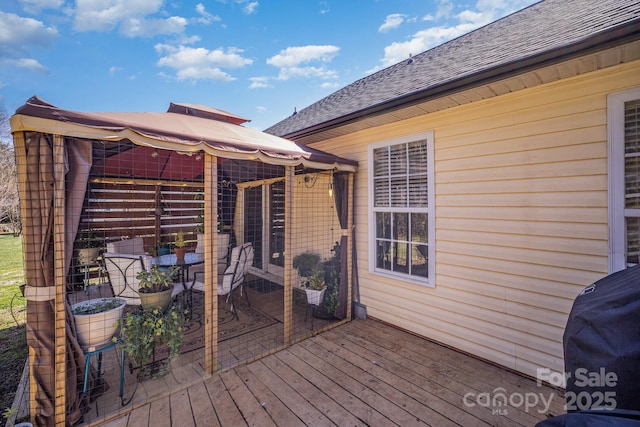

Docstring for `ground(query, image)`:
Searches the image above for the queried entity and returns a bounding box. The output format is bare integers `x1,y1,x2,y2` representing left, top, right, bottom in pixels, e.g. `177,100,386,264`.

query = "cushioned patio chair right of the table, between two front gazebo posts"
191,243,254,320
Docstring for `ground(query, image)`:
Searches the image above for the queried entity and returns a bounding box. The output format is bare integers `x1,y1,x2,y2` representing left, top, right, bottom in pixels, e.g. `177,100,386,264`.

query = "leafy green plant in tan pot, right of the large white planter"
136,265,179,310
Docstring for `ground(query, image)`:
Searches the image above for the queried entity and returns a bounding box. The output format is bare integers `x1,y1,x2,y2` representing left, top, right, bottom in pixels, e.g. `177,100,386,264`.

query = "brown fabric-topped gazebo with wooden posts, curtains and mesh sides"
11,97,357,426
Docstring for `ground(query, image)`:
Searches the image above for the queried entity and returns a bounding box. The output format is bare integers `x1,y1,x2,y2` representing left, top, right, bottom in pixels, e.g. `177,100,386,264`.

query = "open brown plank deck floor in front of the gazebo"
92,319,564,427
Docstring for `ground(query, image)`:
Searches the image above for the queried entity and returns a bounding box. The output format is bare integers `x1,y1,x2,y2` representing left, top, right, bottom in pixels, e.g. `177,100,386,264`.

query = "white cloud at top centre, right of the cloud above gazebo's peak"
267,45,340,80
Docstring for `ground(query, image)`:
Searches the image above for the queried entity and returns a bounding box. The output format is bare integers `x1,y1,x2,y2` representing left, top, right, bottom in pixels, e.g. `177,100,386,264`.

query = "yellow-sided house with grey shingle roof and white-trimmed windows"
266,0,640,382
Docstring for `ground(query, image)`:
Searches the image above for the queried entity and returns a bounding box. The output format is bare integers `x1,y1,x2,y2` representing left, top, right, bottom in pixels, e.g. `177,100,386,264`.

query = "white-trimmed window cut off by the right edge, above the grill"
607,88,640,273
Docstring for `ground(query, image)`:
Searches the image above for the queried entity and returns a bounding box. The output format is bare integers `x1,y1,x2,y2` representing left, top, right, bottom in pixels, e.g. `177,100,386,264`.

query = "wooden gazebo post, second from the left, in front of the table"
204,153,218,374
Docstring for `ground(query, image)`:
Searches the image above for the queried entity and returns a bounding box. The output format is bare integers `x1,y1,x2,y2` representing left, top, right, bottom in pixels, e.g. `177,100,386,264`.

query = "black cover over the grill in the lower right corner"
563,265,640,412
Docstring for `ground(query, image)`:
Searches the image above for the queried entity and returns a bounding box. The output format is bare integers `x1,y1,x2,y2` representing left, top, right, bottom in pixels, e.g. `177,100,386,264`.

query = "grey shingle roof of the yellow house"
265,0,640,136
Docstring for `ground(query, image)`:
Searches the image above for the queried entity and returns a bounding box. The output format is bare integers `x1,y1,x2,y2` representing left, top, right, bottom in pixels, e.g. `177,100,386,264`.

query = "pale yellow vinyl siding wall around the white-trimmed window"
314,61,640,376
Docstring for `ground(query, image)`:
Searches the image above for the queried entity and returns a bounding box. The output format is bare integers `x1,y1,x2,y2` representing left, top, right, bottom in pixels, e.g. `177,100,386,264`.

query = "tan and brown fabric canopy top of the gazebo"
11,96,357,172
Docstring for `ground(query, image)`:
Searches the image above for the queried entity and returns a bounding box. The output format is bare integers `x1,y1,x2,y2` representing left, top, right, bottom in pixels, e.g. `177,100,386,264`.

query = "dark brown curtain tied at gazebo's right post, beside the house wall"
333,173,349,319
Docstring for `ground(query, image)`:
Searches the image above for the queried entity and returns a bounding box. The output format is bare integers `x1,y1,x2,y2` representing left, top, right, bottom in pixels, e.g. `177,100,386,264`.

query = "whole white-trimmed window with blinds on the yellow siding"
369,132,435,286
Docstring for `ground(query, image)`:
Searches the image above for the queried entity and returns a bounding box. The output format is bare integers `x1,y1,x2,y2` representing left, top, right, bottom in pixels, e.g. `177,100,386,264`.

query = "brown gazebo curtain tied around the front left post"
19,133,91,426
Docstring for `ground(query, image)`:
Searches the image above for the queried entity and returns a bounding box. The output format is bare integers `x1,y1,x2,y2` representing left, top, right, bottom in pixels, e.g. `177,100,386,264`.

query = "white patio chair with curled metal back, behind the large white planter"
102,252,184,305
